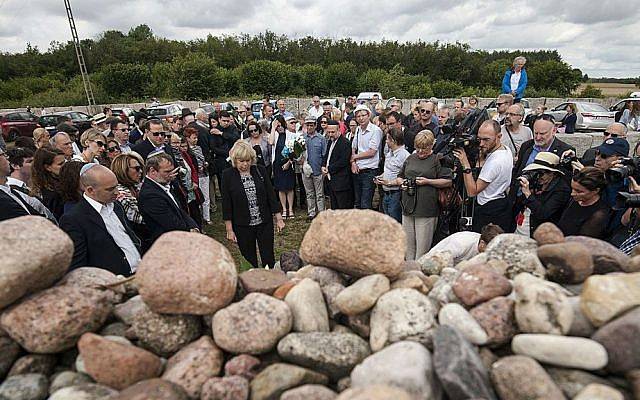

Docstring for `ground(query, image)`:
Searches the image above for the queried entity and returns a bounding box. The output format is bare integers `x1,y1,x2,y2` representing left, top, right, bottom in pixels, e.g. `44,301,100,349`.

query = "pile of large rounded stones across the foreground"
0,210,640,400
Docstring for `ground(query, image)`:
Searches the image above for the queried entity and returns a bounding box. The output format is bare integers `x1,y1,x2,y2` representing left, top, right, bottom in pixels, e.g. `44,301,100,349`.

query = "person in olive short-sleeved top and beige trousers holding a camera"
390,130,452,261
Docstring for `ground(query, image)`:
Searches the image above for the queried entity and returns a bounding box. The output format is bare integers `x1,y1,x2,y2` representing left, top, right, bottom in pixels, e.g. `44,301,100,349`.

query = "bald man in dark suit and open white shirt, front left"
60,164,140,276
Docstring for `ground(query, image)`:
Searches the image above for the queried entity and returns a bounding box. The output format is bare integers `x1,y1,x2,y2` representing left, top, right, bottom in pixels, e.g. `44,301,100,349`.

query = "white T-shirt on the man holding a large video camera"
477,147,513,205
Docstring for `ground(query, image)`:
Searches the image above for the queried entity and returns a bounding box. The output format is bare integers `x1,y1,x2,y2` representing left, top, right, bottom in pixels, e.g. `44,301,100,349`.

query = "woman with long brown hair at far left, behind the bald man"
31,147,66,220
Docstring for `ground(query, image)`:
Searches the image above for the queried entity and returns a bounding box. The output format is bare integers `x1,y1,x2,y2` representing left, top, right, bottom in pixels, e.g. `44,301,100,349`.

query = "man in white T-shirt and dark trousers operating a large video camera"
453,120,513,232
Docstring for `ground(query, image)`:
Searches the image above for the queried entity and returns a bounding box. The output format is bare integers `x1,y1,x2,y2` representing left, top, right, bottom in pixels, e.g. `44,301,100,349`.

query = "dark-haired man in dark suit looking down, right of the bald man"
138,153,199,242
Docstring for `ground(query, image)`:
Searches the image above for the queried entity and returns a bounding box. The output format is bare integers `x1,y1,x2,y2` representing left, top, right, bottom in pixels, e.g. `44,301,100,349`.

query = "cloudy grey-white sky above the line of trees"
0,0,640,77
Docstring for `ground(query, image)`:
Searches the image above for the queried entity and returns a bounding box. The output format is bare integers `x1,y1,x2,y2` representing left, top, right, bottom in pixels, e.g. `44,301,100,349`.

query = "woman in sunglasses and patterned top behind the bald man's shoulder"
111,152,151,252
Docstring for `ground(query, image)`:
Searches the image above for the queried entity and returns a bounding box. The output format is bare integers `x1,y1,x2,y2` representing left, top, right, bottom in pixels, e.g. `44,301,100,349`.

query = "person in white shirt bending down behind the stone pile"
427,224,504,265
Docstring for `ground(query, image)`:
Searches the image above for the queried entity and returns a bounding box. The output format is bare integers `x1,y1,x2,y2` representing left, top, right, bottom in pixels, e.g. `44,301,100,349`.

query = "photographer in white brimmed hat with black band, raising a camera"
516,152,571,236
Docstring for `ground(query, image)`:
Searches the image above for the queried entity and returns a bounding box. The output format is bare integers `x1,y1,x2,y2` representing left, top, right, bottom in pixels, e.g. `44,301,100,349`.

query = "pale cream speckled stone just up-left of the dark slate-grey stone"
369,289,436,351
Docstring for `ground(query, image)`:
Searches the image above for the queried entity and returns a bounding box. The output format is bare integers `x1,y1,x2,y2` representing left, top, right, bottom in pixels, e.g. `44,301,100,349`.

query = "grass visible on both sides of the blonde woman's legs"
205,200,310,271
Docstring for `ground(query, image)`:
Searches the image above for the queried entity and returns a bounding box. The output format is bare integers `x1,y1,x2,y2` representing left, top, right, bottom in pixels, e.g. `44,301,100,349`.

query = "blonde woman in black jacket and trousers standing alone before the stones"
222,140,284,268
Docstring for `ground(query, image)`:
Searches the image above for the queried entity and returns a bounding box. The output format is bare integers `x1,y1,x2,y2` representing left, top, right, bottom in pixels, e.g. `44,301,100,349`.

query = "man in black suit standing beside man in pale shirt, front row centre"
322,120,353,210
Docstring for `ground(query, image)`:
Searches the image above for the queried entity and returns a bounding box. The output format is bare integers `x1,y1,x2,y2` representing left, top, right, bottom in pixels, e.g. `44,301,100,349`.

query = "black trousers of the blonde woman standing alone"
233,218,276,268
